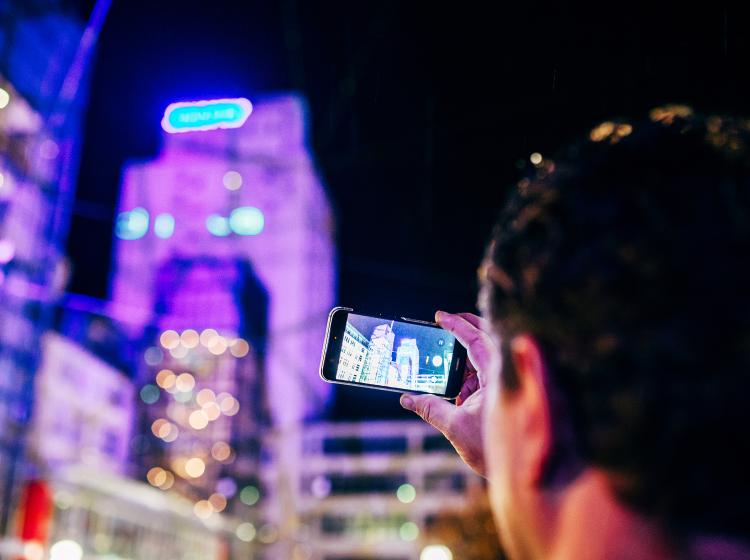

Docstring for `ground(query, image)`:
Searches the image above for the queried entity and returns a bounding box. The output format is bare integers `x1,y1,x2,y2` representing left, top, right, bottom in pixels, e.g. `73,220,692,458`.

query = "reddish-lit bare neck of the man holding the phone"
549,469,677,560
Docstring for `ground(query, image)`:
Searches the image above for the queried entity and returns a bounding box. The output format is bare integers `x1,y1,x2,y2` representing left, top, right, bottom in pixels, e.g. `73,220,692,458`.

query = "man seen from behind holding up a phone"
401,106,750,560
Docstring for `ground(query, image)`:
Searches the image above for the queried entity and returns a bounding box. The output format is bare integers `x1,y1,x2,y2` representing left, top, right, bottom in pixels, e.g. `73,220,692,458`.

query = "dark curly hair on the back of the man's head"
480,105,750,538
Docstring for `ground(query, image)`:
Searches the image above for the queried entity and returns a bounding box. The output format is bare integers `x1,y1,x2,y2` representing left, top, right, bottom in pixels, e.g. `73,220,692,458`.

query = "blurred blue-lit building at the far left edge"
0,0,96,534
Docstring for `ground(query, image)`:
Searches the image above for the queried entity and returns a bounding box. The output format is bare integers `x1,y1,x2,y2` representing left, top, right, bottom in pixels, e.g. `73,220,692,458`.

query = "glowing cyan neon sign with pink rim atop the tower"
161,97,253,134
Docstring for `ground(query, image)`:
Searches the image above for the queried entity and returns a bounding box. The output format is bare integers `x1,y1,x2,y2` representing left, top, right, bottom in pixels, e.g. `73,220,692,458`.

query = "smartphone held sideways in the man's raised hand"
320,307,466,399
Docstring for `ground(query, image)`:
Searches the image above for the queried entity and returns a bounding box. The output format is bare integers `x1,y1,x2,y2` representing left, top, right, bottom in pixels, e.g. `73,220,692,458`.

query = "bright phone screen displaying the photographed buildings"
336,313,456,395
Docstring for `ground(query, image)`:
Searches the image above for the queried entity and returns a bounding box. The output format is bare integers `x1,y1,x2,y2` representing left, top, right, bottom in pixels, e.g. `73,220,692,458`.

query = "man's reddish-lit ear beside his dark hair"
510,334,554,486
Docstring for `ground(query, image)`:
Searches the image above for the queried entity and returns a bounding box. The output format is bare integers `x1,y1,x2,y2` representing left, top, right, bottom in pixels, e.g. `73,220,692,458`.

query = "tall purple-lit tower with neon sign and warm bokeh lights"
110,96,335,558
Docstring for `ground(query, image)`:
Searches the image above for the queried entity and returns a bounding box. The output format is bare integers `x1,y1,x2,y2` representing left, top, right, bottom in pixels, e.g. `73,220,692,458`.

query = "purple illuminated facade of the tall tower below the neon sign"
111,96,335,425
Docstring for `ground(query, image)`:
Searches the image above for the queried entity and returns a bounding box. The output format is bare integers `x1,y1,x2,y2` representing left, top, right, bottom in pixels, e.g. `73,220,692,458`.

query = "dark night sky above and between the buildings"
68,0,750,418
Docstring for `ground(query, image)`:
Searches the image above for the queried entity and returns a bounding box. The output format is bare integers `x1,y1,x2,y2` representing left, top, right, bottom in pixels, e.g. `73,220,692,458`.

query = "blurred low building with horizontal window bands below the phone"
280,421,484,560
